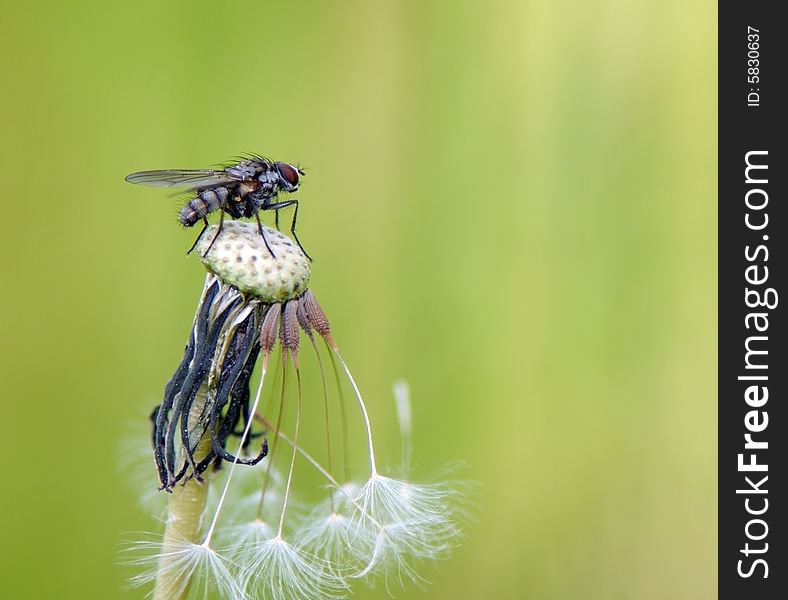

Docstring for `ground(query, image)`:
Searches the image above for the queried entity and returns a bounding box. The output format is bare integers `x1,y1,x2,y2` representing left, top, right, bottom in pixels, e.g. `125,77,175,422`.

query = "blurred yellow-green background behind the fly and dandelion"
0,0,717,600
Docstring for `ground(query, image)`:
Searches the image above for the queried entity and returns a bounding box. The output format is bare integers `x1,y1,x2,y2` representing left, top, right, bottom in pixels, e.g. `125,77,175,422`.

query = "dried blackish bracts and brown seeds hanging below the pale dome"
151,275,332,491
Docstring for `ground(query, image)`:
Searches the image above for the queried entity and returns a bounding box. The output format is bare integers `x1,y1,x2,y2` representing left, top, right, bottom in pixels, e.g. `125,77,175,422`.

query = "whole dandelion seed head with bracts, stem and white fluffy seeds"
126,221,460,600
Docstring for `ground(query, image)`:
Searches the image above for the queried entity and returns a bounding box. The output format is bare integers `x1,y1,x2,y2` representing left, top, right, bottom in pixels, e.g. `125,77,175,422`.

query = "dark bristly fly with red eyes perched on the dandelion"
126,156,311,260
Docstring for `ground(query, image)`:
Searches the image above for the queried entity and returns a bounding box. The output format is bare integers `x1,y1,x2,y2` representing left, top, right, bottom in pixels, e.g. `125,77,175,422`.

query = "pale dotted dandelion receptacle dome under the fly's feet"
194,221,311,303
